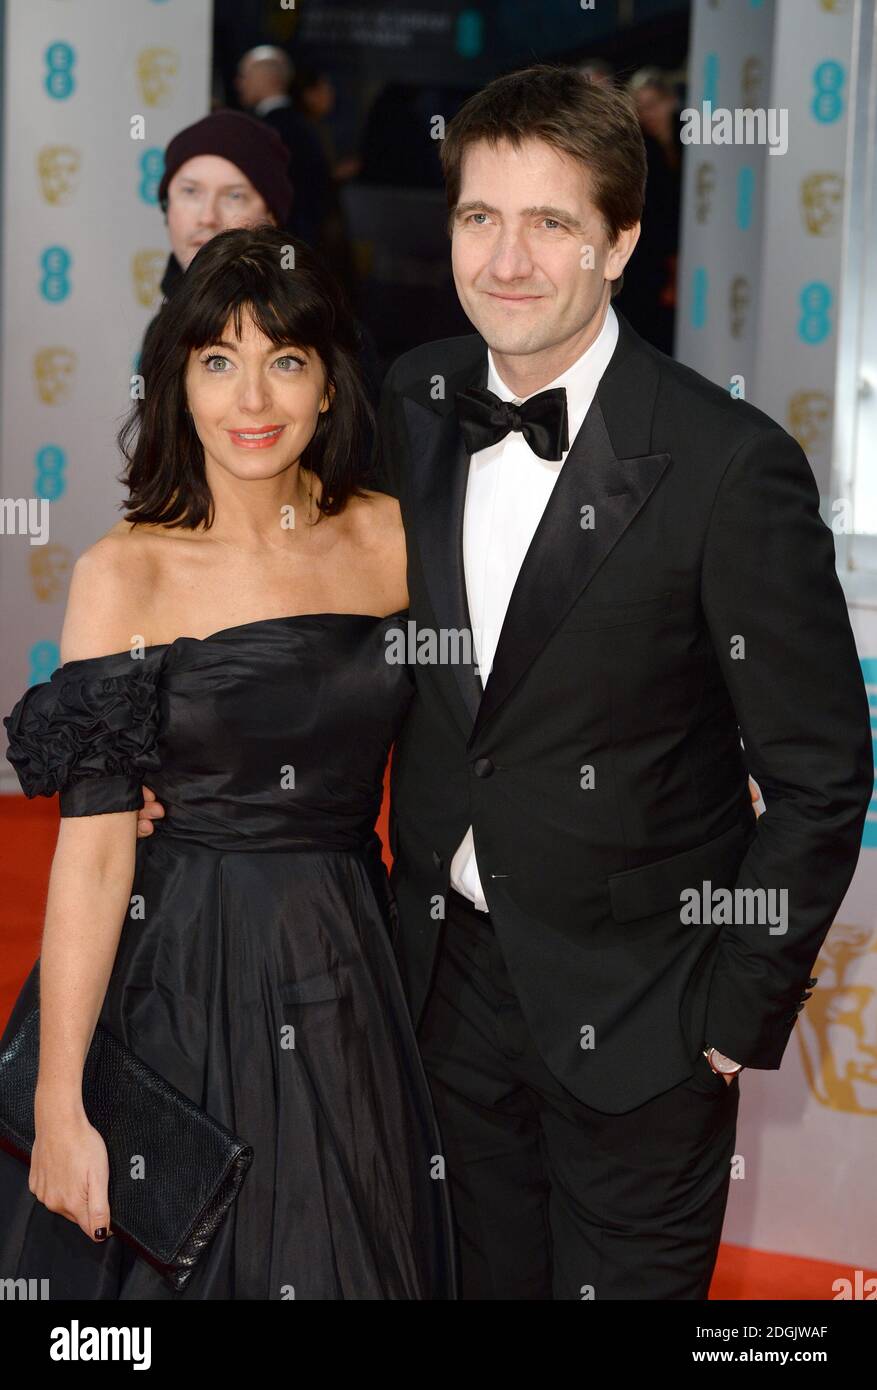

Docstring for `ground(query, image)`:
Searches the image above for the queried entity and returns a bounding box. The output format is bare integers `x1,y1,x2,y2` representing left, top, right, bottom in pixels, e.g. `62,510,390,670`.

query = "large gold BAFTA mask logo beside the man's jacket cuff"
798,923,877,1115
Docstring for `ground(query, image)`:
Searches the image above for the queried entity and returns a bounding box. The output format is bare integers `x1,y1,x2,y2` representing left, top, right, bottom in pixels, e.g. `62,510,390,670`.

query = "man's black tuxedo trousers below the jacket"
418,890,739,1300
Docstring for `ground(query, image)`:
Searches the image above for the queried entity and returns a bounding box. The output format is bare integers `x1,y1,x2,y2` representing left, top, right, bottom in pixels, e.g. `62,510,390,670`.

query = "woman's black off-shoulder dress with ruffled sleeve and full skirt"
0,613,457,1300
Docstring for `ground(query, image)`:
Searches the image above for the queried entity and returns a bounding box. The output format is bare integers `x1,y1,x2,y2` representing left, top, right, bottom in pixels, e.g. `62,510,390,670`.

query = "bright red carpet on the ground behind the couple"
0,795,877,1301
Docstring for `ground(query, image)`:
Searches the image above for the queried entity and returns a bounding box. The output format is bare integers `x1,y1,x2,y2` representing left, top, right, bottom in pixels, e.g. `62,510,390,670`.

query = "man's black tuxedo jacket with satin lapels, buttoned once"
377,310,873,1113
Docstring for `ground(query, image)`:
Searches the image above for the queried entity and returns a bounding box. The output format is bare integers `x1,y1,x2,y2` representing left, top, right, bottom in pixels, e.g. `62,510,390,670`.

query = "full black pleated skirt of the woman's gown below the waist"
0,835,457,1300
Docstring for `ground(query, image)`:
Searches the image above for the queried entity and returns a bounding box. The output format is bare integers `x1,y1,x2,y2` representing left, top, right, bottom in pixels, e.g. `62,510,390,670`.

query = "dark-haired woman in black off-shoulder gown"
0,228,456,1300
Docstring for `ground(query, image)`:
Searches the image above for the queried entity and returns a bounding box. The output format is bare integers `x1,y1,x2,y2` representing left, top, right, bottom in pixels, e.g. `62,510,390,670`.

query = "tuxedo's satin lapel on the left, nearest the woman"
404,386,486,734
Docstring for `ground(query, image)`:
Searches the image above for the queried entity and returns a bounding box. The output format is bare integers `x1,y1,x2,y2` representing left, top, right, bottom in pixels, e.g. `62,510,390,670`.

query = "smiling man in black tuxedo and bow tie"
379,68,873,1300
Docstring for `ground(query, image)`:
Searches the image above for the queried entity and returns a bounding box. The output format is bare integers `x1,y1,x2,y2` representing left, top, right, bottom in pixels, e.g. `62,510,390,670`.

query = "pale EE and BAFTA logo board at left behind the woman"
0,0,213,728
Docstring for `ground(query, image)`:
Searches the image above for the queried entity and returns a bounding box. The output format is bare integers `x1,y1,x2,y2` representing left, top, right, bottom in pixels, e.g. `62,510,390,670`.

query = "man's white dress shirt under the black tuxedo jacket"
450,304,618,912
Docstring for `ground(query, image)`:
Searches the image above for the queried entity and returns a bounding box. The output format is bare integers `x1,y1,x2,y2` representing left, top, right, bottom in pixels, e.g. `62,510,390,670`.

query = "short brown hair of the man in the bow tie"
441,64,646,296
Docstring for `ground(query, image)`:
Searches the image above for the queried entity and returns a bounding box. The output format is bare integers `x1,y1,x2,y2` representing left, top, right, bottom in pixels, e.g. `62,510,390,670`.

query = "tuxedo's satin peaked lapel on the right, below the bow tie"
470,391,670,744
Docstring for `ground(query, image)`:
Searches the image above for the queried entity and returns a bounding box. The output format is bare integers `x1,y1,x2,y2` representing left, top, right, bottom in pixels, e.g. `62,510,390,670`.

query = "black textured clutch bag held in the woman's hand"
0,1008,253,1290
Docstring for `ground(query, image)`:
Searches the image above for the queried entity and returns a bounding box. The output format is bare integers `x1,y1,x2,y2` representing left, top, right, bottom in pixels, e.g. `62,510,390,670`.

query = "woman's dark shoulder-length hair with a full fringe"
118,224,374,530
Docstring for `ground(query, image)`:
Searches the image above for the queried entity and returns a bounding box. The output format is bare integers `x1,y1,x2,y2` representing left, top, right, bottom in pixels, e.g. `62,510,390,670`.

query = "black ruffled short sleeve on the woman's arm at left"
3,649,161,816
